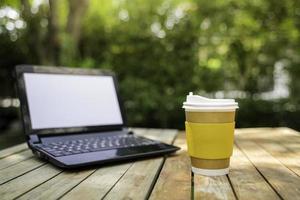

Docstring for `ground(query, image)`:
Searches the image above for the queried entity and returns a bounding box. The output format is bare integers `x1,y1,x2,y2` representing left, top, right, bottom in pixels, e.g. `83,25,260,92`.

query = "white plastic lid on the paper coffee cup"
183,92,238,112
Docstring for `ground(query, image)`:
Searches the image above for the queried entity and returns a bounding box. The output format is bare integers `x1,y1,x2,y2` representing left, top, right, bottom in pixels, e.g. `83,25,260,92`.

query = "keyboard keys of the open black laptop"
38,135,159,157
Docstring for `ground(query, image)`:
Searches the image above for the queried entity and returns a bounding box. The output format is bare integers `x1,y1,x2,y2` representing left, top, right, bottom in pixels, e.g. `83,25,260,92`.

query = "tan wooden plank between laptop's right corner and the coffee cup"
150,132,191,200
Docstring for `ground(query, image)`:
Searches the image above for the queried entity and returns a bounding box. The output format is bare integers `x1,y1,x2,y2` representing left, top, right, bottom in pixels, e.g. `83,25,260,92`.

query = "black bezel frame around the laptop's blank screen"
15,65,127,136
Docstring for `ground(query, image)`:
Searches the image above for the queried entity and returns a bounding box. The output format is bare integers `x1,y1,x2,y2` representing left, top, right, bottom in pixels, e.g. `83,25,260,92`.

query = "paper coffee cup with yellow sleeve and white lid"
183,93,238,176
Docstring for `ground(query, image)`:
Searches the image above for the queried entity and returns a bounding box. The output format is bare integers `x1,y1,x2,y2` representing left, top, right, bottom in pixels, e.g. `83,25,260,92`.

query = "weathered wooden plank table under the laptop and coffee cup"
0,128,300,200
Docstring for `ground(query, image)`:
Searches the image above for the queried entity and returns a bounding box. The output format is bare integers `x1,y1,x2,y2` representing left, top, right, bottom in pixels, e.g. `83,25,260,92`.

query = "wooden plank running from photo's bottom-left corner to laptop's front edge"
0,164,60,200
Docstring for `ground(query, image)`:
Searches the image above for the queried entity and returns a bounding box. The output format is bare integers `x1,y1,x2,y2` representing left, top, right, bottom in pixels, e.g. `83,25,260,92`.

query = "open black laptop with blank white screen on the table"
16,65,179,168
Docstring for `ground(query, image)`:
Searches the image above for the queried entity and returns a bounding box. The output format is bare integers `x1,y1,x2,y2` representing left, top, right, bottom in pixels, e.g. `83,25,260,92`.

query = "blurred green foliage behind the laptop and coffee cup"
0,0,300,128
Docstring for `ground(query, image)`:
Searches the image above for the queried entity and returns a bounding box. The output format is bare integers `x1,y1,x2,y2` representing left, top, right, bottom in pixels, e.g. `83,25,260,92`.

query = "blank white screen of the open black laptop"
24,73,123,129
